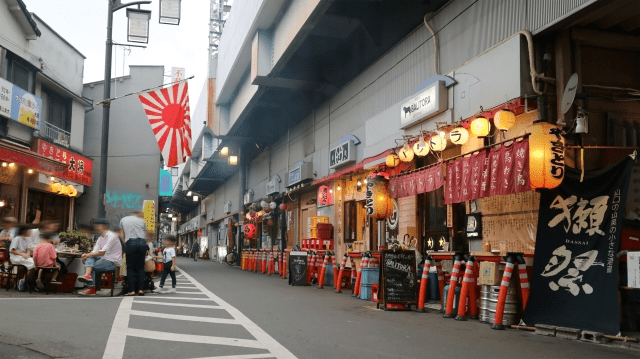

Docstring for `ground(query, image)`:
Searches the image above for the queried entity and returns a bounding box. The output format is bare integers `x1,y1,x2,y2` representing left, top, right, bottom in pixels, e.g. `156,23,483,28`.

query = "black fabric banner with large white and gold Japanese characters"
523,157,633,334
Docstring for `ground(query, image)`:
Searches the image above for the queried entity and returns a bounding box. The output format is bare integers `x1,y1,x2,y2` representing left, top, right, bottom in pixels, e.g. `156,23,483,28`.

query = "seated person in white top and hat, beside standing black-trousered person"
78,218,122,296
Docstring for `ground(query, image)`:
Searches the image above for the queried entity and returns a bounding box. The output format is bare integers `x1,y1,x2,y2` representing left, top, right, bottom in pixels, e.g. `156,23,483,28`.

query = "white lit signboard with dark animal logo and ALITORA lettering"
400,81,448,128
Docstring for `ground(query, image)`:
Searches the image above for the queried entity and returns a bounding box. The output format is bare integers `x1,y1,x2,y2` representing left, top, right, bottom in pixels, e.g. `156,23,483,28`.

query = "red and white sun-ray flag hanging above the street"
139,81,191,167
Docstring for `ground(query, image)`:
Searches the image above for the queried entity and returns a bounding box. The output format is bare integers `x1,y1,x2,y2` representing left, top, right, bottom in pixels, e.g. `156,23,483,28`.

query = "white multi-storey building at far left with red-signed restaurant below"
0,0,93,229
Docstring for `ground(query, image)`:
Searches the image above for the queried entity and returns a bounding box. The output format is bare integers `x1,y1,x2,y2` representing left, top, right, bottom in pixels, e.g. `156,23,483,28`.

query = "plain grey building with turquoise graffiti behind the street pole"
79,66,164,231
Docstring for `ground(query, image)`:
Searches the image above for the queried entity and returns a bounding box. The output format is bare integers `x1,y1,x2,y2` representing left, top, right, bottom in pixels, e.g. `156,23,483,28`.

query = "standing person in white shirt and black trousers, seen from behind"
120,212,149,296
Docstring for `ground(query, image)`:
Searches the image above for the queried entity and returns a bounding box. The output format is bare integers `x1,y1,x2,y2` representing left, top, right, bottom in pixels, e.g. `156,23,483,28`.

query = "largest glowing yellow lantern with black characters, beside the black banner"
528,122,564,189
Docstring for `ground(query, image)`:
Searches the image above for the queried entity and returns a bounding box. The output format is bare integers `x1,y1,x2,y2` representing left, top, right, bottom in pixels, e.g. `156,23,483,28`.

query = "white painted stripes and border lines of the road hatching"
103,268,296,359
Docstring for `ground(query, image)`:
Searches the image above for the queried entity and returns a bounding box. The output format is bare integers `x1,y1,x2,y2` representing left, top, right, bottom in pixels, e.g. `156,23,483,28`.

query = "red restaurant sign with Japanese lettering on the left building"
38,140,93,186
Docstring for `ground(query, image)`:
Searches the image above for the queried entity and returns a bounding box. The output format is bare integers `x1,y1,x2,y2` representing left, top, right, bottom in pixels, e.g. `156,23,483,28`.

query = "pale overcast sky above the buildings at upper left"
24,0,209,136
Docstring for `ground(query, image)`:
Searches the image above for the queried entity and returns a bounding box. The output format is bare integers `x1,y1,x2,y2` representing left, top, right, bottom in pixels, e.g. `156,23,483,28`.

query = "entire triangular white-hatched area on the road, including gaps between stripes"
103,268,295,359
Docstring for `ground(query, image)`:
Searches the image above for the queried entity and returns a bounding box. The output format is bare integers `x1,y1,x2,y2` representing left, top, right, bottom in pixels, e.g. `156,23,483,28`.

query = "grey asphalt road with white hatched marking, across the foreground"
0,258,640,358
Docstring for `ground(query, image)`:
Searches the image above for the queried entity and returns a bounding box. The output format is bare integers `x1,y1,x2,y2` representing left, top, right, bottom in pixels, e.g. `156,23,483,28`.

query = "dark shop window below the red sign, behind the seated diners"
27,190,70,230
